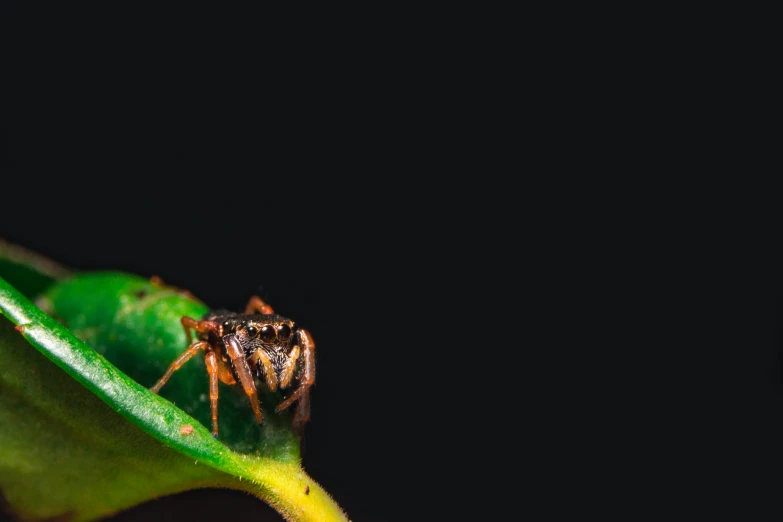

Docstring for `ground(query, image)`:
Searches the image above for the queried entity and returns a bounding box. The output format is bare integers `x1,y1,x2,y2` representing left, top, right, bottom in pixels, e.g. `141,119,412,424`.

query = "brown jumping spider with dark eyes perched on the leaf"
150,296,315,437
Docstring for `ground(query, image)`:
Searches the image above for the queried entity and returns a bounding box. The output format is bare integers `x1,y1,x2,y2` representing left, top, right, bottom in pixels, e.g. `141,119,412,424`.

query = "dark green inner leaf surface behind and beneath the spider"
37,272,300,463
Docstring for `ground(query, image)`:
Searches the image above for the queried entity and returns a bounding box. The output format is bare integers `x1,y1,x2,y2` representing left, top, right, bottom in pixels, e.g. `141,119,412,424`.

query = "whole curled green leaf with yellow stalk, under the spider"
0,249,346,521
